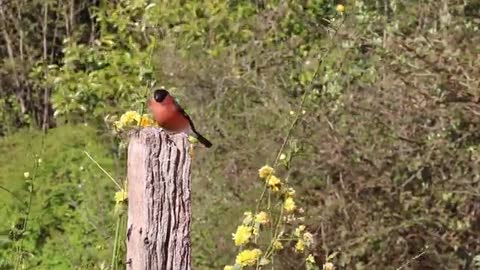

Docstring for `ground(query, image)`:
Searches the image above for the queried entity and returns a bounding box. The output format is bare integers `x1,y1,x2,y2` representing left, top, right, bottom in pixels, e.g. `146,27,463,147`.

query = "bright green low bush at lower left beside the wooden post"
0,126,118,269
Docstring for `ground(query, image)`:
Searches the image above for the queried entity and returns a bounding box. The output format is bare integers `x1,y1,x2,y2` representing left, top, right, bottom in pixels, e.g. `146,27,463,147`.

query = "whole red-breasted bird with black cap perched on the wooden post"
148,88,212,147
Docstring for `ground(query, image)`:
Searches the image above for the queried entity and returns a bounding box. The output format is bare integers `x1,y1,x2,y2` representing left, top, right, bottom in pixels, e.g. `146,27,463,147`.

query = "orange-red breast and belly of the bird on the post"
149,95,190,132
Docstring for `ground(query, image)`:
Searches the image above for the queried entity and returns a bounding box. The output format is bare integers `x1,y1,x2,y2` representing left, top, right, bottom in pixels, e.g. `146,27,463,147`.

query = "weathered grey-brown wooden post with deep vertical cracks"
126,128,191,270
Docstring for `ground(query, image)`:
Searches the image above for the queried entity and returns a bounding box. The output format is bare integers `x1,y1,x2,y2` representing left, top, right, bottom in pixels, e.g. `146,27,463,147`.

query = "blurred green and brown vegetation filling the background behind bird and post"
0,0,480,270
